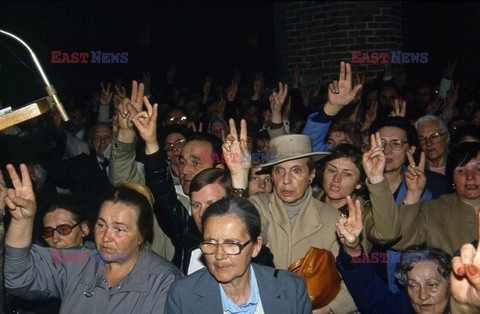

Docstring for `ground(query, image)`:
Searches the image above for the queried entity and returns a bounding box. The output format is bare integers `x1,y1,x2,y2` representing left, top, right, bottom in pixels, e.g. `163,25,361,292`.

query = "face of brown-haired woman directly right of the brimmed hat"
322,157,362,206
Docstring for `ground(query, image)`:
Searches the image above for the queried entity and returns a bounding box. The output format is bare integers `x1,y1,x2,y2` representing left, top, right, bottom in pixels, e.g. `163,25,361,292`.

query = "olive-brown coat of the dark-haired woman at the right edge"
394,193,478,254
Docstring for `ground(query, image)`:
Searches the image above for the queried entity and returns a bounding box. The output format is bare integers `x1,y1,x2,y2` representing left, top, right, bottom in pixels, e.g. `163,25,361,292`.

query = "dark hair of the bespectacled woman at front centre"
202,196,262,242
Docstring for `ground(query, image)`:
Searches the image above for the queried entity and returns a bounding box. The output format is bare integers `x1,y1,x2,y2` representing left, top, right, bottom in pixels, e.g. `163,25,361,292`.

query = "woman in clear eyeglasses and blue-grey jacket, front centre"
164,197,312,314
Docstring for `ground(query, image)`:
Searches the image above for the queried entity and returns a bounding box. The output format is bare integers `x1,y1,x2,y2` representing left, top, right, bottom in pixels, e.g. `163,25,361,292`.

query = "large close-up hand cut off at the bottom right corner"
450,215,480,313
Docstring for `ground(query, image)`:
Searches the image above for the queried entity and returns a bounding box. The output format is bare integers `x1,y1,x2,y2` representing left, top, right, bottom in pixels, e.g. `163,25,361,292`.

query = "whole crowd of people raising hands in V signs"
0,57,480,313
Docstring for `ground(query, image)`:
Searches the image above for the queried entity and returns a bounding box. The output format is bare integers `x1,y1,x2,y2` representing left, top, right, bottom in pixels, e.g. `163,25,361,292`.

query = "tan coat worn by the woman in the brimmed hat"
250,187,356,313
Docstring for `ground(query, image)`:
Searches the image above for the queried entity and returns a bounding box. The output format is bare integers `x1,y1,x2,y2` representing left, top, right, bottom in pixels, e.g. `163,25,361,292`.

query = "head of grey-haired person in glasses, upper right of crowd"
415,115,450,175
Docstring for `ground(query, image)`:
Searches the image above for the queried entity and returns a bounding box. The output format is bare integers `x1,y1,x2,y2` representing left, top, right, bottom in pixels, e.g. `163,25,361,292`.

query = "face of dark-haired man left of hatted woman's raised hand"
179,141,213,195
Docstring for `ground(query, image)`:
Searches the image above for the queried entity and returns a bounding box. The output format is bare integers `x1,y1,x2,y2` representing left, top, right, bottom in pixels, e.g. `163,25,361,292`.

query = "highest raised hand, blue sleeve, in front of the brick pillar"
328,61,362,107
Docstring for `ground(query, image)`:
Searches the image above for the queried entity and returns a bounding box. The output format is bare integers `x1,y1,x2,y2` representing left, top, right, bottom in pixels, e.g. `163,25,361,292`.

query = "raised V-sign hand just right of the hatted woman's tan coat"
335,195,363,252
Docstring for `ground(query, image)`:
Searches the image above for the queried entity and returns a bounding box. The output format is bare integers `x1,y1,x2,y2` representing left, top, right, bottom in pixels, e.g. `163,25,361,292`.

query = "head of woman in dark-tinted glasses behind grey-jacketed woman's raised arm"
42,195,90,249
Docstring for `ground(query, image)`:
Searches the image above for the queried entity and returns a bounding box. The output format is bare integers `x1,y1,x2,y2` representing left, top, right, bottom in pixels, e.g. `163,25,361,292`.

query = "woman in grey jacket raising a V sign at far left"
4,164,182,313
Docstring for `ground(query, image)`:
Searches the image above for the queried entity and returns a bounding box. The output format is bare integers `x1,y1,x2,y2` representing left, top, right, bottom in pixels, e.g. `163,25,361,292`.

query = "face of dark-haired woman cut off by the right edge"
453,154,480,200
